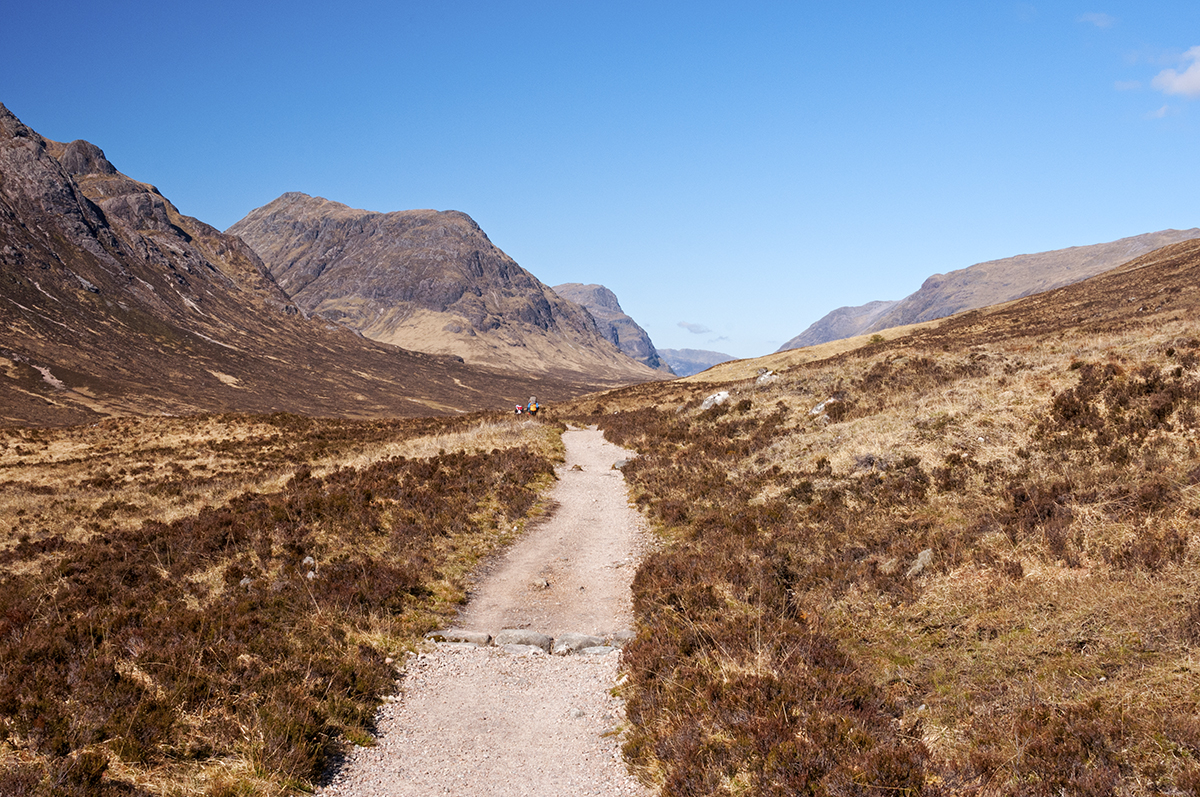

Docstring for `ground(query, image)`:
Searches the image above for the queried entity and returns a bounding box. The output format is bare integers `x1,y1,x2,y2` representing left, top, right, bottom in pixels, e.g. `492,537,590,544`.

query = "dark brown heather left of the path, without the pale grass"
0,415,553,796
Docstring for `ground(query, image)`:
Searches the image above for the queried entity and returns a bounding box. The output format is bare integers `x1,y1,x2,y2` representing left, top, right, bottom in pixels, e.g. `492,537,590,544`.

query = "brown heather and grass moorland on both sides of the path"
7,237,1200,797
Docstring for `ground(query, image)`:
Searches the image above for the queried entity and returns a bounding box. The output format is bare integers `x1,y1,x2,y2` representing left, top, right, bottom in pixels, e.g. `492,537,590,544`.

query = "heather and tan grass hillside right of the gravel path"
561,245,1200,795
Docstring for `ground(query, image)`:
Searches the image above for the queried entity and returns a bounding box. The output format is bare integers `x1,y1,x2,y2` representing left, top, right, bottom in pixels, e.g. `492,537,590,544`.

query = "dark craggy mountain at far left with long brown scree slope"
0,104,648,424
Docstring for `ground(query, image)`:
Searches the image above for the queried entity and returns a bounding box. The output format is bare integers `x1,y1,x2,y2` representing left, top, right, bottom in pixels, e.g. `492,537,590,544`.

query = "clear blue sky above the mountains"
0,0,1200,356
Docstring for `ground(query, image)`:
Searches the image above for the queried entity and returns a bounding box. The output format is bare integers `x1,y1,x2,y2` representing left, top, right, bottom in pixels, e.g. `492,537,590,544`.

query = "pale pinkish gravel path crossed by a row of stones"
317,430,650,797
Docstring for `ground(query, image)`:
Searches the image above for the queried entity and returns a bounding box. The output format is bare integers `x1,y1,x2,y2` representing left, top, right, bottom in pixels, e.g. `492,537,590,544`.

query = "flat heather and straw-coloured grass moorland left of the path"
0,415,560,797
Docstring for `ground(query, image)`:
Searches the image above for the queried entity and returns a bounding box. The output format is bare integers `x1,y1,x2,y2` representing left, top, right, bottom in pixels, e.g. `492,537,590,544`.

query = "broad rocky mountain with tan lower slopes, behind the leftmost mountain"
227,193,661,382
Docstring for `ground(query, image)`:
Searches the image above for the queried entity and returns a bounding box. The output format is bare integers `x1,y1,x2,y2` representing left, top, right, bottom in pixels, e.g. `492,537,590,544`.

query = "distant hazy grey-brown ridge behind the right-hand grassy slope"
779,228,1200,352
